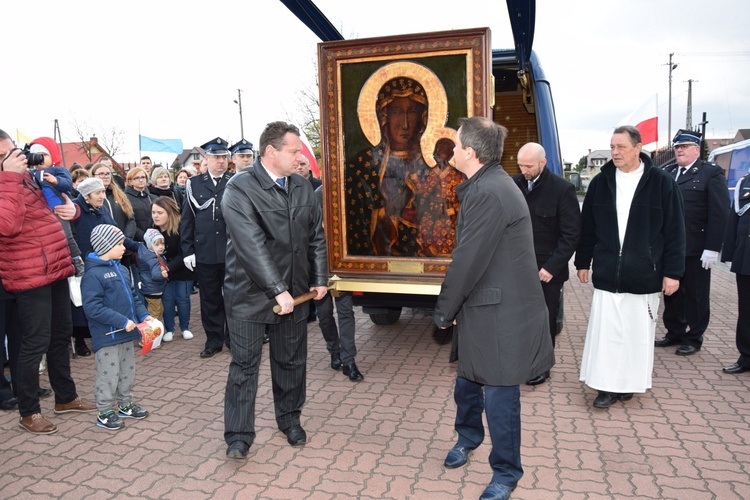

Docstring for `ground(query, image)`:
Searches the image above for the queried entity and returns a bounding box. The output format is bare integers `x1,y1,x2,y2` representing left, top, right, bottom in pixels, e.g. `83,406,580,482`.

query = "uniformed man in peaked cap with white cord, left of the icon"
180,137,231,358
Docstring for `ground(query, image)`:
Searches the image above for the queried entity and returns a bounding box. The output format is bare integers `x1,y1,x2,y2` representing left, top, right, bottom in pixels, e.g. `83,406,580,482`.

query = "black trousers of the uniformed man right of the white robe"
664,257,711,347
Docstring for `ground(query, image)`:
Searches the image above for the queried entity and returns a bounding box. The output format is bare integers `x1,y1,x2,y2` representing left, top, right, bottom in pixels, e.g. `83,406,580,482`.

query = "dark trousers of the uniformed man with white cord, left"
195,263,229,349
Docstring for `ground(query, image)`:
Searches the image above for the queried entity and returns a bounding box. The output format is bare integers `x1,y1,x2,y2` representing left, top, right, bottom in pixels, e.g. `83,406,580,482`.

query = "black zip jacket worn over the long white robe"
575,153,685,294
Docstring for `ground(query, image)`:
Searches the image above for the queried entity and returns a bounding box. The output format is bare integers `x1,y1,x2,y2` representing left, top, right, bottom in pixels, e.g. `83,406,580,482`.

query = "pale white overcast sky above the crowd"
0,0,750,167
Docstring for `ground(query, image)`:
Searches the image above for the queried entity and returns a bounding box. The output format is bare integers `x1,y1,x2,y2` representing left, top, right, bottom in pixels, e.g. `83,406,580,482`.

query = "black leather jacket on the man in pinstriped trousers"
222,159,328,323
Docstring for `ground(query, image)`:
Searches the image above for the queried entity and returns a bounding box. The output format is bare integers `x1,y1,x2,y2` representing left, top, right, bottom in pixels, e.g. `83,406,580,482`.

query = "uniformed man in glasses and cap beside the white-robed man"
654,130,729,356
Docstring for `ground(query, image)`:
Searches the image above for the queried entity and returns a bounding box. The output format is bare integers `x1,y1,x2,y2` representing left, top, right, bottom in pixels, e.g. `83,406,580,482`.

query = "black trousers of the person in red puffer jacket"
14,279,78,417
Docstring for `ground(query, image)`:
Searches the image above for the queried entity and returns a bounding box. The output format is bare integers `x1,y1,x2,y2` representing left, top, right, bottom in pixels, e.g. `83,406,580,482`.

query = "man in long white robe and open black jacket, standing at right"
575,125,685,408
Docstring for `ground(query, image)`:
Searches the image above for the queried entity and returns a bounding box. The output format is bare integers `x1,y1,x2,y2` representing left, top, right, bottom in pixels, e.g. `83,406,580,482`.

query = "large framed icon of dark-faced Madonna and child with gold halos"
318,28,492,277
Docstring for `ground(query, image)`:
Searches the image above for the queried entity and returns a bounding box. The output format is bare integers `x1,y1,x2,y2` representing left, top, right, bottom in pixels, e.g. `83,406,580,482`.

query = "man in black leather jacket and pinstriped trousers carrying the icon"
222,122,328,459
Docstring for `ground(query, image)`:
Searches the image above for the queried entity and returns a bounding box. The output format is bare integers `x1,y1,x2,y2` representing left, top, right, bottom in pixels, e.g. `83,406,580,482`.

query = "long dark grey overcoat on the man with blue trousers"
434,162,555,386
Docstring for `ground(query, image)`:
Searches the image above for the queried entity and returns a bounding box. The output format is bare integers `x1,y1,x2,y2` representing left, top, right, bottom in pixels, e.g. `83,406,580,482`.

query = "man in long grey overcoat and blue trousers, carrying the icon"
433,117,555,499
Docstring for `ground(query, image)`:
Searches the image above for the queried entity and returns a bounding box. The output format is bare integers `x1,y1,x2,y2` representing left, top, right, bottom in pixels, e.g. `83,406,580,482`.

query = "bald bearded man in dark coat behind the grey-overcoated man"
513,142,581,385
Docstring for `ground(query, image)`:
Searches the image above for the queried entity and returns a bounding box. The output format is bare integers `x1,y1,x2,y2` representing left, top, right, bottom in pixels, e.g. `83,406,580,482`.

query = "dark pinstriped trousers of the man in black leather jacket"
225,316,307,445
